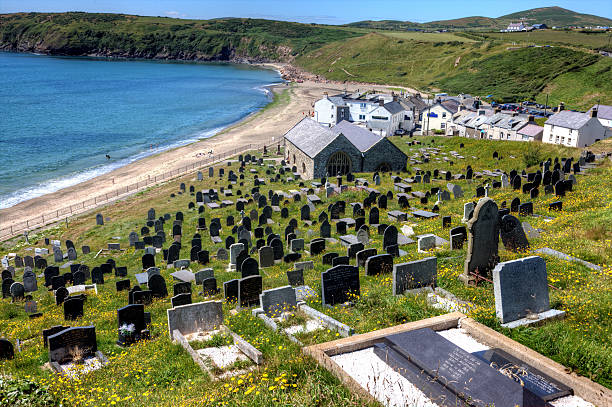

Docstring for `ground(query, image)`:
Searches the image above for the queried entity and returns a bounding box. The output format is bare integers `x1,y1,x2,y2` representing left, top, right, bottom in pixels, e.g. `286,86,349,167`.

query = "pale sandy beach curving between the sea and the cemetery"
0,64,414,236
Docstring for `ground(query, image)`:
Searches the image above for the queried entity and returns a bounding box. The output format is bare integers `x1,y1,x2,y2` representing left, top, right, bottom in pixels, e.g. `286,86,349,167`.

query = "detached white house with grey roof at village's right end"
542,109,606,147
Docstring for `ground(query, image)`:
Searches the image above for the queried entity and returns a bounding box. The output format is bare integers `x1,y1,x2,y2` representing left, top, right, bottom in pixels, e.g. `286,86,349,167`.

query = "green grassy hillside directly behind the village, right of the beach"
296,32,612,109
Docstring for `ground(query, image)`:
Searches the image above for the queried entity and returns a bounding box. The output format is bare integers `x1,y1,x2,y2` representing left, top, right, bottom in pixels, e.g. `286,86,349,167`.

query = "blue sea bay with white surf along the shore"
0,52,280,208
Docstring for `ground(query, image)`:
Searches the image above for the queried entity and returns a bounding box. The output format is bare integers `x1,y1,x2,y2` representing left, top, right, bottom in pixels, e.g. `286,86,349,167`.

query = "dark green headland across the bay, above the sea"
0,13,362,61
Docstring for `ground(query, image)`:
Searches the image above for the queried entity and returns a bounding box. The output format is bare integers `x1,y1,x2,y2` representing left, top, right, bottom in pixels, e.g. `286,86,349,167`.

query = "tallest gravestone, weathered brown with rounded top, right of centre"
461,198,499,284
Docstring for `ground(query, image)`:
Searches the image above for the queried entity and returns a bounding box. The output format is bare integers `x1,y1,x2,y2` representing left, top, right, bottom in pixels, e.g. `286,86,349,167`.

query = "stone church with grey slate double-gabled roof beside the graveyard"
284,117,408,179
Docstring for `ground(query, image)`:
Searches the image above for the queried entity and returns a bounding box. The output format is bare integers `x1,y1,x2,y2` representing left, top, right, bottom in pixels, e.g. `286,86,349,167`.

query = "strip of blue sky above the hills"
0,0,612,24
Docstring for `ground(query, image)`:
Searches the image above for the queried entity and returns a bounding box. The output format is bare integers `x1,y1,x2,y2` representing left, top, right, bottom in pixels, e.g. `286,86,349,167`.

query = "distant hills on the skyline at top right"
348,7,612,30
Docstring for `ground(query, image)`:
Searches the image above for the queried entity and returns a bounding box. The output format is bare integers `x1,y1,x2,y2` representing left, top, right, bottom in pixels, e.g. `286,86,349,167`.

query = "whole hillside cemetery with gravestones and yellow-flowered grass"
0,136,612,407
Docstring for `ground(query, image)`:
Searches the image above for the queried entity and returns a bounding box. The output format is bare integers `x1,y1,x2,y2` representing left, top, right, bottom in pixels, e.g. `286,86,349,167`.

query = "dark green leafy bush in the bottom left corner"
0,377,59,407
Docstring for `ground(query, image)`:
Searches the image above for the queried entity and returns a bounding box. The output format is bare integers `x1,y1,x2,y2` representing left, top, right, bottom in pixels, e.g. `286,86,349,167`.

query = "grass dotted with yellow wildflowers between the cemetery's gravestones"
0,138,612,407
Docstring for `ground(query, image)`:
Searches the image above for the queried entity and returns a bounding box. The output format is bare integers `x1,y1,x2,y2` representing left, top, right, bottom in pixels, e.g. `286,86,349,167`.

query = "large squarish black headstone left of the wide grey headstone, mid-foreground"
321,265,361,306
